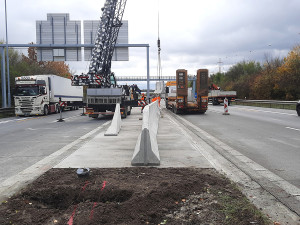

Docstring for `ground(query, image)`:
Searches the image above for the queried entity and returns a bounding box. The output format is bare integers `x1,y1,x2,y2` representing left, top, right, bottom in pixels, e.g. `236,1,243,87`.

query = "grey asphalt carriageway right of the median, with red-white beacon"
182,105,300,188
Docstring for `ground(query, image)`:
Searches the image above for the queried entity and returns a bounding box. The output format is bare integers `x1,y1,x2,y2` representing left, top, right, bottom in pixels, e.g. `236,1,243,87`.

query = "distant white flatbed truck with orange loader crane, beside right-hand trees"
208,84,236,105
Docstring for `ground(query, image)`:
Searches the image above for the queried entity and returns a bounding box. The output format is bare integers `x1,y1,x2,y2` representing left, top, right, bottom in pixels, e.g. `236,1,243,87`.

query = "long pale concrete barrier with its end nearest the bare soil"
131,101,160,166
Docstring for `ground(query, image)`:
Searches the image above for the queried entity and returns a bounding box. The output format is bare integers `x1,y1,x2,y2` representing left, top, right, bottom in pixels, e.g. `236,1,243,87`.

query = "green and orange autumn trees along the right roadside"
210,45,300,101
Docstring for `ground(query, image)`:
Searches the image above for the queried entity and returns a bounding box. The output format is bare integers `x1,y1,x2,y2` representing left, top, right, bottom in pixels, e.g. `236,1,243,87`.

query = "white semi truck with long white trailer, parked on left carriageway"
14,75,83,116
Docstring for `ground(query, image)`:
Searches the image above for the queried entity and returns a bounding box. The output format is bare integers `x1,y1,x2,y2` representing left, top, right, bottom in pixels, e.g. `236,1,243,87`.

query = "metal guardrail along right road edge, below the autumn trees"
232,99,298,110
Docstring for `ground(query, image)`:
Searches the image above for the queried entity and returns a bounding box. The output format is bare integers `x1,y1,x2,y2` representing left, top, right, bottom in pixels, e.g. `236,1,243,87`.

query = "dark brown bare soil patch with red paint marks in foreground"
0,167,268,225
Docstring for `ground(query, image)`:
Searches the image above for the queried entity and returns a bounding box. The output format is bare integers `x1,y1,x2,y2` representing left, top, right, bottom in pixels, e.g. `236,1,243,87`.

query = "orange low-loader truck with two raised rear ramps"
166,69,208,114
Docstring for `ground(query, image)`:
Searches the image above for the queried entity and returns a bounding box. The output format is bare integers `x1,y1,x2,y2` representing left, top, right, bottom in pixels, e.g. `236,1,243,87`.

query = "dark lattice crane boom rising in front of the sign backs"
72,0,127,88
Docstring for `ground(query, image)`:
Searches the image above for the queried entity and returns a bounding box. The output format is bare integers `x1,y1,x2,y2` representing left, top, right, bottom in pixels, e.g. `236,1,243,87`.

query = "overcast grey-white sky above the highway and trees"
0,0,300,80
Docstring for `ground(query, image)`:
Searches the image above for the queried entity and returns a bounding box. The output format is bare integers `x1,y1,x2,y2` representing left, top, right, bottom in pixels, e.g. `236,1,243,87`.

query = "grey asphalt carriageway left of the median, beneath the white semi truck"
0,110,111,183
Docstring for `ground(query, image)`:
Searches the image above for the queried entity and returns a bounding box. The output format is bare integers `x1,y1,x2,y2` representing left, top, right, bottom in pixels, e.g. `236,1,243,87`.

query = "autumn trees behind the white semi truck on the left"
0,41,71,106
